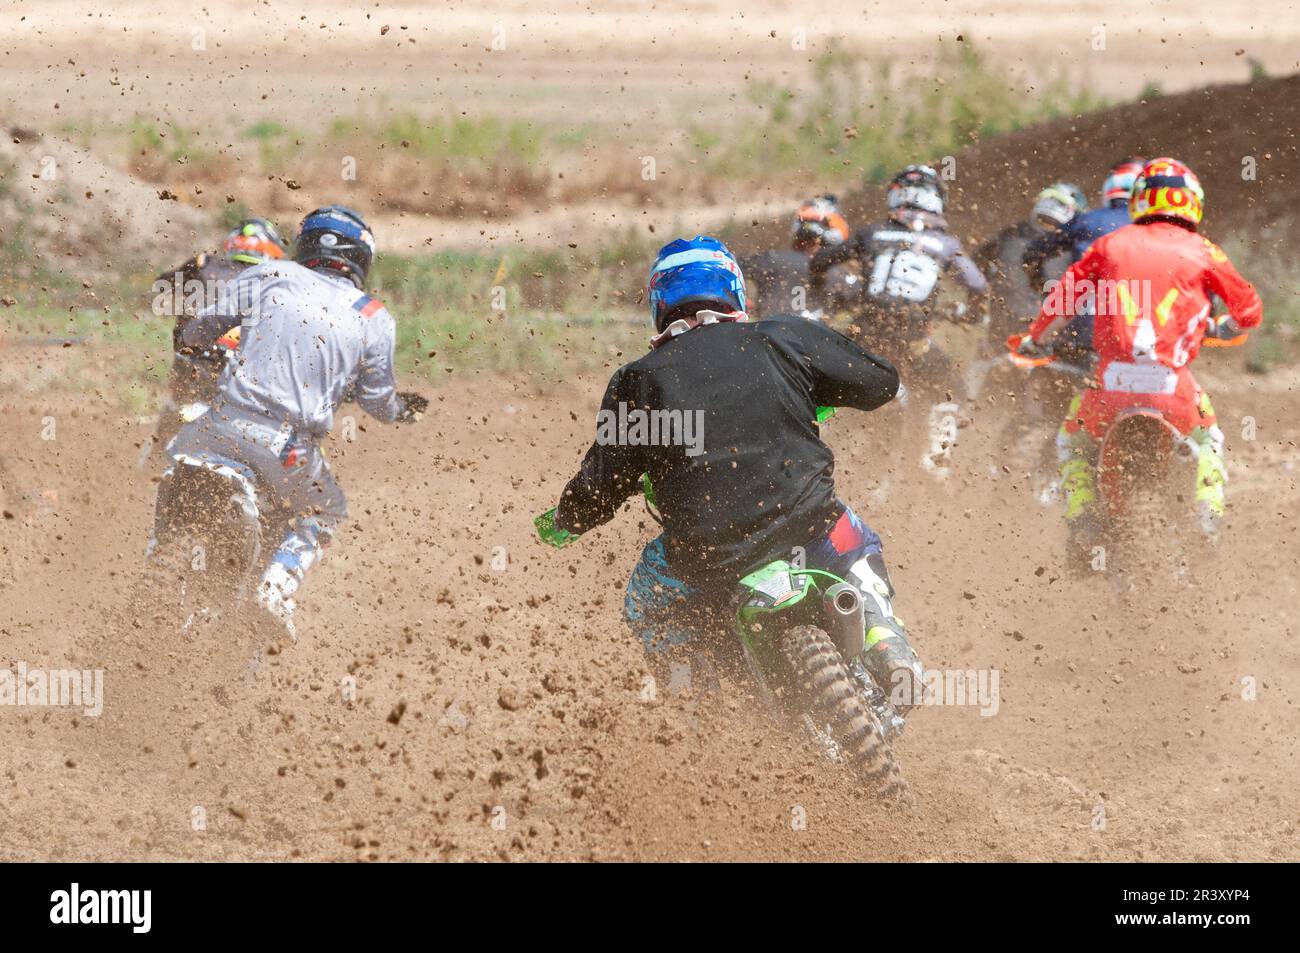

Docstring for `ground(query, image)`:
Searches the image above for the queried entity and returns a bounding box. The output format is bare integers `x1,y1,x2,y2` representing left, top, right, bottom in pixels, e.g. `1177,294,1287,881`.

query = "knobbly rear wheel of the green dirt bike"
781,625,911,802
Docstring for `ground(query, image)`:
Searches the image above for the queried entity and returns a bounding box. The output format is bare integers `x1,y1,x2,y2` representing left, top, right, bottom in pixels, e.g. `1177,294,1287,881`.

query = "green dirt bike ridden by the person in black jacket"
534,447,910,802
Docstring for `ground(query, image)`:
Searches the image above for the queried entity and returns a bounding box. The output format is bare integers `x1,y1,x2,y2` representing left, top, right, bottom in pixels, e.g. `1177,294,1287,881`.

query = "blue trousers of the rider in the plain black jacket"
623,507,893,654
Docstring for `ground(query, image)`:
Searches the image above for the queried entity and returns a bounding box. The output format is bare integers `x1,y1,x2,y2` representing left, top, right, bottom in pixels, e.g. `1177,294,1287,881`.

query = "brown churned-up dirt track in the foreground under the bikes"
0,345,1300,859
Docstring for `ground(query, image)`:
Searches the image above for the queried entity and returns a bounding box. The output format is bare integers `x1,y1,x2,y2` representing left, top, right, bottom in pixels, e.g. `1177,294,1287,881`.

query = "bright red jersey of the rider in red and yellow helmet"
1030,221,1264,374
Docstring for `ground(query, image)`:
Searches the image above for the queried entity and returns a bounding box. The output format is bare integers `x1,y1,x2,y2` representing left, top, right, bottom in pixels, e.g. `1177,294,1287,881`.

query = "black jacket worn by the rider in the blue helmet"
560,319,898,586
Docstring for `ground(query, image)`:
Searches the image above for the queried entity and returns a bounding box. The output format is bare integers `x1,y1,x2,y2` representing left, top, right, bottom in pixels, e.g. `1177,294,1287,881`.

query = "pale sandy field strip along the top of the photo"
0,0,1300,122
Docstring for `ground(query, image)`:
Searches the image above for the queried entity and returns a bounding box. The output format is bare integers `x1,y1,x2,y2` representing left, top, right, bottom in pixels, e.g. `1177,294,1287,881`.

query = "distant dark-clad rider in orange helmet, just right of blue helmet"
740,195,849,320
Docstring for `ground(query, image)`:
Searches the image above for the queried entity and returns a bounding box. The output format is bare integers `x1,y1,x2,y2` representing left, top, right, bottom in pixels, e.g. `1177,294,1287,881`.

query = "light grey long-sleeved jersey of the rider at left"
182,261,402,439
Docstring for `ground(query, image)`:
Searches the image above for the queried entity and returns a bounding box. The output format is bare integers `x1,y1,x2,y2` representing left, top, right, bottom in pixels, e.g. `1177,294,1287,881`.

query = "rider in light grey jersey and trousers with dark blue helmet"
158,205,428,636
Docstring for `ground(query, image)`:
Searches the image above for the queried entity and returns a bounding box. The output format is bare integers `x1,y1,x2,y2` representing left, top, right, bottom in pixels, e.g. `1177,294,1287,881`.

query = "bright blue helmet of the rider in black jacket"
649,235,745,332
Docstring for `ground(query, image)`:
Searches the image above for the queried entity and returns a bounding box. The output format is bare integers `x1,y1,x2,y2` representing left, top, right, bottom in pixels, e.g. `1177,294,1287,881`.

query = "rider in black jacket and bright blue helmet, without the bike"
547,235,920,707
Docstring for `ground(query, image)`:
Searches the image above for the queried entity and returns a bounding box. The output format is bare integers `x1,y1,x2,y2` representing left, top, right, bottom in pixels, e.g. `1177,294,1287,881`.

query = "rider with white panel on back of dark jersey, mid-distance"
810,165,988,476
